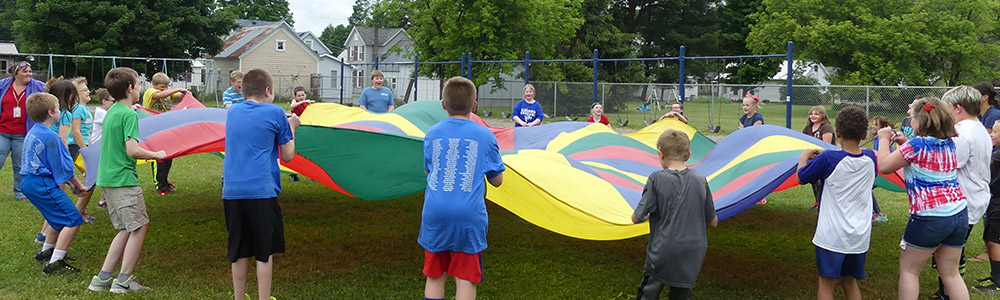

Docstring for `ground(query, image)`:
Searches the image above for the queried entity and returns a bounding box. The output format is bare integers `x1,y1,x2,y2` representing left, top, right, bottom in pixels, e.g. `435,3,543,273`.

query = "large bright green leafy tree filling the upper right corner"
747,0,1000,85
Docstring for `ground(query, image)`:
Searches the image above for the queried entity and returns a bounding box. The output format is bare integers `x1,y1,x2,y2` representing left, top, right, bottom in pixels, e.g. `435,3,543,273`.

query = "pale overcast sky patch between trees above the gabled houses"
288,0,354,37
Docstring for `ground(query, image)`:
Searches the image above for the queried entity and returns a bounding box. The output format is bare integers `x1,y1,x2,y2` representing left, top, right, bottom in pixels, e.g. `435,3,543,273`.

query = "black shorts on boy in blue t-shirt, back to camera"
222,198,285,262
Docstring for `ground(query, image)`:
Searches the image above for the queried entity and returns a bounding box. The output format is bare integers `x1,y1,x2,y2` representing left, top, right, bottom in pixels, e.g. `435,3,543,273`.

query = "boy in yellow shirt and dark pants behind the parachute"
142,73,188,196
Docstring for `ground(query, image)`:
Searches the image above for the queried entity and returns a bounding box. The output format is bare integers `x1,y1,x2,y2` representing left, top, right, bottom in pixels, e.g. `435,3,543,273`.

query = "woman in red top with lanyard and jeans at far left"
0,62,45,201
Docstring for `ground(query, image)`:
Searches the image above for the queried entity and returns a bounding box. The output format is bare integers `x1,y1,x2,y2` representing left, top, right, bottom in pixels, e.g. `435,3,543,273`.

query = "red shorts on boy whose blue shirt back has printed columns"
424,250,483,283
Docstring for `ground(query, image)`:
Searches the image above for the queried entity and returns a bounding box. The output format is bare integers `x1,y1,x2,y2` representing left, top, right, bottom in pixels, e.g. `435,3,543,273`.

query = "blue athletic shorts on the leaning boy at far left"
21,175,83,231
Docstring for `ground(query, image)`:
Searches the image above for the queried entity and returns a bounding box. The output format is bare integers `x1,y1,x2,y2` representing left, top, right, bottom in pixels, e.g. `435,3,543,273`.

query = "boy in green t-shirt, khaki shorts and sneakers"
89,67,167,293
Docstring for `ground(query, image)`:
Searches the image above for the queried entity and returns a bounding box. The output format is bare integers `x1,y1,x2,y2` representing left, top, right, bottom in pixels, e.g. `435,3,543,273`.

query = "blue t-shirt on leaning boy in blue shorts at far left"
20,122,76,184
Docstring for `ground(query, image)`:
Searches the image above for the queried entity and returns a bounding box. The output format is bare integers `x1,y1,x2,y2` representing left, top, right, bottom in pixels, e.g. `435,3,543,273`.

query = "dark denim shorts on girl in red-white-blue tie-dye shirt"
903,209,969,250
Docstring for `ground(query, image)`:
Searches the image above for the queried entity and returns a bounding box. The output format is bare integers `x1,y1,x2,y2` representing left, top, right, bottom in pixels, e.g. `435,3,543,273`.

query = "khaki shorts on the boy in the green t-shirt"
101,185,149,232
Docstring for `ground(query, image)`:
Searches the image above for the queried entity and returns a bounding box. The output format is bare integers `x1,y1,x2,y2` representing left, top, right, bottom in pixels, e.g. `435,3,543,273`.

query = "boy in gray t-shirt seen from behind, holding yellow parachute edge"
632,129,719,300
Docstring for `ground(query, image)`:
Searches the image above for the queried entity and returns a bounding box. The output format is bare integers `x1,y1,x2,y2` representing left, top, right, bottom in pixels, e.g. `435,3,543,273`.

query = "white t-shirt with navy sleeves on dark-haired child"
798,149,876,254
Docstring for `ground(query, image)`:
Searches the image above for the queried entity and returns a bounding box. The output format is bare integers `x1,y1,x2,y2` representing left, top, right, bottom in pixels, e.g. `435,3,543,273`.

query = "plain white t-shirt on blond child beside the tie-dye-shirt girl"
952,120,993,225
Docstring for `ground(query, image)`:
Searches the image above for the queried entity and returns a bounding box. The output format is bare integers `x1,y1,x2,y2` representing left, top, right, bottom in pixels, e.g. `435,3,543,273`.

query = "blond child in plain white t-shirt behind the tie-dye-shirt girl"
940,85,992,295
